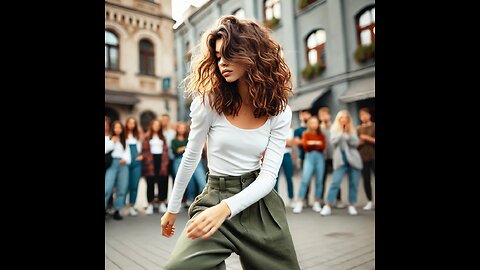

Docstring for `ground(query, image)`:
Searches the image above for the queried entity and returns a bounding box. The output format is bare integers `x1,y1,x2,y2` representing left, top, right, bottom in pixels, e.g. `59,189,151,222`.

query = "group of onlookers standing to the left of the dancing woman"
105,114,206,220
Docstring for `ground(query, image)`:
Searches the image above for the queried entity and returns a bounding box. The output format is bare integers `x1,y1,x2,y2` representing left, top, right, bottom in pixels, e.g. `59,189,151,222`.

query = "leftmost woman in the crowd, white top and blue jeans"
105,121,130,220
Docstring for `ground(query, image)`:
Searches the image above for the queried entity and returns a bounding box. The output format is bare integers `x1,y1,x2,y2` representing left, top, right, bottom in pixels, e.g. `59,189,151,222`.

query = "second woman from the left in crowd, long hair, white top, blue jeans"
125,117,143,216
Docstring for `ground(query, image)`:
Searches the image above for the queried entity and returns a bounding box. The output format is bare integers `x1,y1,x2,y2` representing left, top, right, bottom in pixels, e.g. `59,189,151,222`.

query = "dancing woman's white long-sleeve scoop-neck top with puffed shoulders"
168,97,292,218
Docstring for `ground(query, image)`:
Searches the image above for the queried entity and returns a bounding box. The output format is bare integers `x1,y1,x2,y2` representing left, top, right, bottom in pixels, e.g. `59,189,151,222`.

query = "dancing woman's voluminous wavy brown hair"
186,15,292,118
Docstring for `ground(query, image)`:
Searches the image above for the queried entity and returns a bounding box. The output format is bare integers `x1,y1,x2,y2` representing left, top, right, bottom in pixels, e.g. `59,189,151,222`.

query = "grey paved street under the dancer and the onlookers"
105,174,375,270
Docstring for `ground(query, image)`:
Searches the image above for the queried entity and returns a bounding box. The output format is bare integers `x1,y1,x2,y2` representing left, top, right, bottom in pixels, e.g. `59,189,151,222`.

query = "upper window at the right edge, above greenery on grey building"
356,6,375,45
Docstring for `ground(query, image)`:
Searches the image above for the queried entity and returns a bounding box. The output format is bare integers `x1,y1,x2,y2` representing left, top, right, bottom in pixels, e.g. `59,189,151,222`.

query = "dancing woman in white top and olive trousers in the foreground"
161,16,300,270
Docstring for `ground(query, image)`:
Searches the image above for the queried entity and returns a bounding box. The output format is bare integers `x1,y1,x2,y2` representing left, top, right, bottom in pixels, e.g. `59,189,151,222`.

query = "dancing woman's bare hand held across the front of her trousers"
187,202,231,239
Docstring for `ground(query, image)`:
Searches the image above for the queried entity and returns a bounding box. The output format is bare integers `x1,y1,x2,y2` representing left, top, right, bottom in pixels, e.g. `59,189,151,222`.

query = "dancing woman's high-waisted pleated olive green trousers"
165,170,300,270
